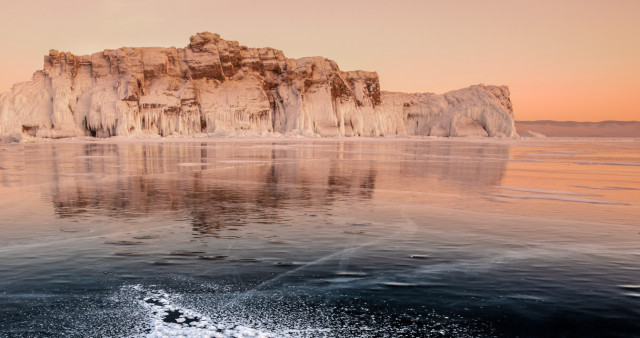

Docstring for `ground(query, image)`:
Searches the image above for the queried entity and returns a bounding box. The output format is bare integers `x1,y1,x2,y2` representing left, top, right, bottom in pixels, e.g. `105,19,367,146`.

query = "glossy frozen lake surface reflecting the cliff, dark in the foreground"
0,139,640,337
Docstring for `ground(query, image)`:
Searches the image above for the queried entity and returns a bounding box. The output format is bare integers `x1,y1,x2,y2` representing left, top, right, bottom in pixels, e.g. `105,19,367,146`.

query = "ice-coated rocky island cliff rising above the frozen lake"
0,33,515,138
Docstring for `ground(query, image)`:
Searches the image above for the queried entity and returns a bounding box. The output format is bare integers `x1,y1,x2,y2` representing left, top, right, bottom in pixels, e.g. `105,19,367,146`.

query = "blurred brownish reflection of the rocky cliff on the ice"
2,141,509,234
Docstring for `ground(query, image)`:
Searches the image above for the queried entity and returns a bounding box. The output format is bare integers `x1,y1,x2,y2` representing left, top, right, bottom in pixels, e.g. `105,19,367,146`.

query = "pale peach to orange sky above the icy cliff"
0,0,640,121
